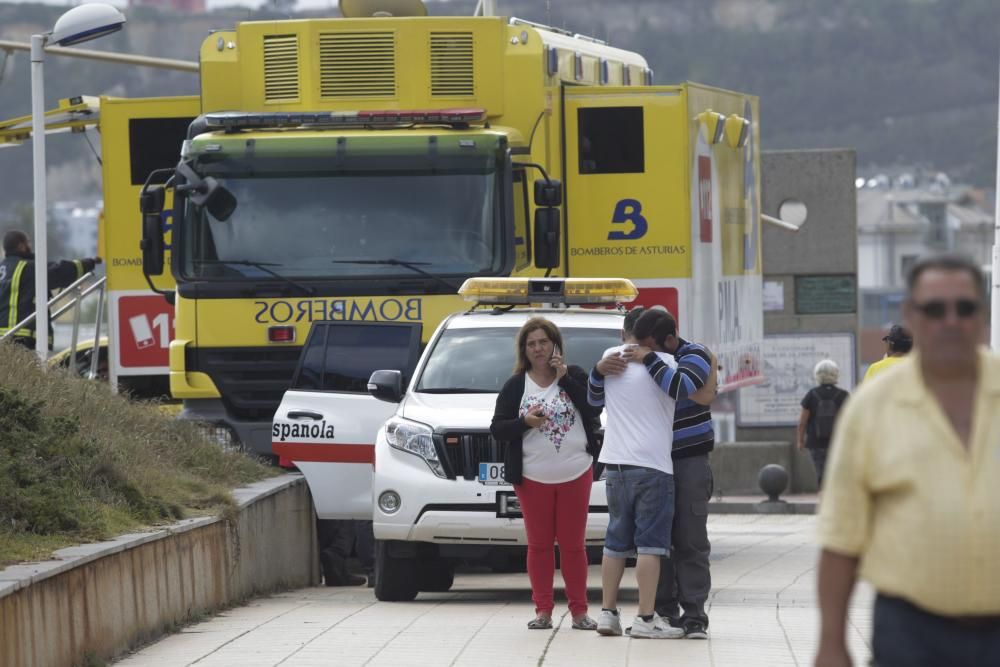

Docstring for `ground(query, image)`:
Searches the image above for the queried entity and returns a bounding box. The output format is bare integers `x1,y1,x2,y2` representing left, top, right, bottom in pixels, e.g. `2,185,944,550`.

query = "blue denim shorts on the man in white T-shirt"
604,466,674,558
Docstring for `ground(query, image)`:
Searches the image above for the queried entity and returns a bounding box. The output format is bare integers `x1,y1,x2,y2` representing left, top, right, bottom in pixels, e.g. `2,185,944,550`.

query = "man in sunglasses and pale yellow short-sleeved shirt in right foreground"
816,255,1000,667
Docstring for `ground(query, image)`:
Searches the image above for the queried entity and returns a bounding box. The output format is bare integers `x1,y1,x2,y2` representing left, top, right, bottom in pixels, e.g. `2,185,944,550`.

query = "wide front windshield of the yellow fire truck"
174,160,506,284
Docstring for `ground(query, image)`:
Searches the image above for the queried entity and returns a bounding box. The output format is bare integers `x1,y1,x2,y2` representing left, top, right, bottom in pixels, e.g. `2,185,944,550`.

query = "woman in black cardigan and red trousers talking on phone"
490,317,601,630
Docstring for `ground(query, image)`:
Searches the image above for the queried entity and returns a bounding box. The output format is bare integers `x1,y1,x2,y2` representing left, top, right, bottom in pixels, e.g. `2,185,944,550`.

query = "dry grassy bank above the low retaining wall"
0,344,279,567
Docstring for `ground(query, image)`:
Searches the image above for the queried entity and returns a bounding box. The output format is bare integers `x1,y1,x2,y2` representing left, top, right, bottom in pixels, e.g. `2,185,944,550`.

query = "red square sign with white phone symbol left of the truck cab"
117,294,174,368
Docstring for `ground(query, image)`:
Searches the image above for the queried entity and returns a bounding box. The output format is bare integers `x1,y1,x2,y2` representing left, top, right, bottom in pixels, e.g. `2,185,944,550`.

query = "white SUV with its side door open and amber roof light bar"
273,279,635,600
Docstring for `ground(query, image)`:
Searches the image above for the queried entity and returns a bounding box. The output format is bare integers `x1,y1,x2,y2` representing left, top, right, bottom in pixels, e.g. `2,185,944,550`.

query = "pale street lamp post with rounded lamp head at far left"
31,3,125,362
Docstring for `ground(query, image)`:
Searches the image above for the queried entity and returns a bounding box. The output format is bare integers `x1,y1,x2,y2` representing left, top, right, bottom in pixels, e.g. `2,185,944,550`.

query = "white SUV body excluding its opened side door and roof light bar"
371,282,636,600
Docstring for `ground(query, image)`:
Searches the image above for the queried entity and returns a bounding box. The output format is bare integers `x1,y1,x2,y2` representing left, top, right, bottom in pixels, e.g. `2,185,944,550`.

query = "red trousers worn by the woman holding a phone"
514,468,594,616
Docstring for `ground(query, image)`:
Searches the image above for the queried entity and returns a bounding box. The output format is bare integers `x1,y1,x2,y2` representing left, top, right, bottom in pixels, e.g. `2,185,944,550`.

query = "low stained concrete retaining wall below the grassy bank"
0,475,319,667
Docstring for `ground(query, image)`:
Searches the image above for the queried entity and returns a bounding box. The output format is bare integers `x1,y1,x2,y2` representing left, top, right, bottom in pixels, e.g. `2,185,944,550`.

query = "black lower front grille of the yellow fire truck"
186,347,302,421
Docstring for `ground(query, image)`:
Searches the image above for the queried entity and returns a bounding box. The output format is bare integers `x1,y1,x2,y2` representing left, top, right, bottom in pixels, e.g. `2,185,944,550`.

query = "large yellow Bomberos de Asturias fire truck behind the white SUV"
5,2,763,454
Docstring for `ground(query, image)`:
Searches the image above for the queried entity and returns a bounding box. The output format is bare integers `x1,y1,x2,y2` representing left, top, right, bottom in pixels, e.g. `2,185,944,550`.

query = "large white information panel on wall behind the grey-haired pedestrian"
736,333,855,427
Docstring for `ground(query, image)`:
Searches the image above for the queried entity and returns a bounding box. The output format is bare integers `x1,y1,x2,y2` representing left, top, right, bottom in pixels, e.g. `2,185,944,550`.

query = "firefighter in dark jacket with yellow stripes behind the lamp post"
0,229,101,350
